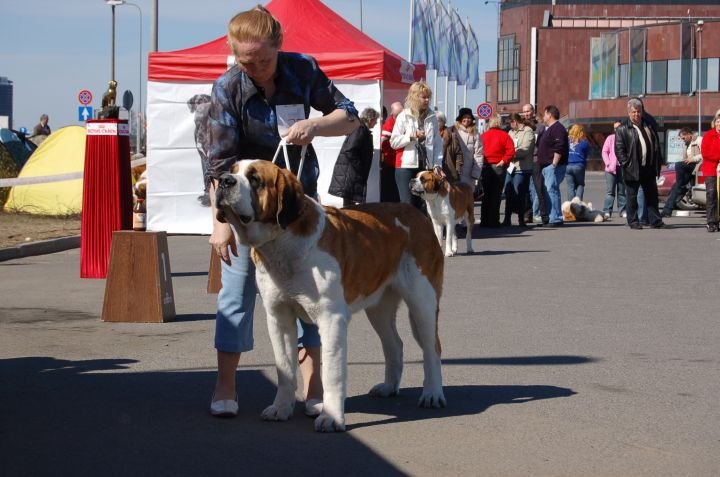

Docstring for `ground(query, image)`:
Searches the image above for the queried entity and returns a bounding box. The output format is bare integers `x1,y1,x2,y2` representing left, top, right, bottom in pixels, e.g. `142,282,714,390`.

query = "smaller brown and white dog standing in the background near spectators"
410,171,475,257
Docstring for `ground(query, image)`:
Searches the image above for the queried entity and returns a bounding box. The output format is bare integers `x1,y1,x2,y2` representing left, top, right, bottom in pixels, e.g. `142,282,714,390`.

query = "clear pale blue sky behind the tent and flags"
0,0,498,130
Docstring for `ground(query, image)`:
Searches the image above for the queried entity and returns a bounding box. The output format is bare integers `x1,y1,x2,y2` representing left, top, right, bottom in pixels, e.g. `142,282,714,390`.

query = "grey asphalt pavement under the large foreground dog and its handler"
0,174,720,477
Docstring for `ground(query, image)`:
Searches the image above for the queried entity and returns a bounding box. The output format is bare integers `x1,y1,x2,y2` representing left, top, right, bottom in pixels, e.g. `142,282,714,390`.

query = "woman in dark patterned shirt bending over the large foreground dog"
205,5,360,416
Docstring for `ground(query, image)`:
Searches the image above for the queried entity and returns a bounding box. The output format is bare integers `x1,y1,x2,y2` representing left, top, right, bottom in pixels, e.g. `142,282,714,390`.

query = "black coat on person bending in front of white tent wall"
328,124,373,203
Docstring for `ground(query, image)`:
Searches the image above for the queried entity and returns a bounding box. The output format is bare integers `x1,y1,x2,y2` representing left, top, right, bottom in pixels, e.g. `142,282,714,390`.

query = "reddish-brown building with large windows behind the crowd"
485,0,720,162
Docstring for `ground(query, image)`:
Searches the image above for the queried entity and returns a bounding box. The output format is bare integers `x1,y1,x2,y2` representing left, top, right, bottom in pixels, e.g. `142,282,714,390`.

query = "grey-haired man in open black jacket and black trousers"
615,98,665,230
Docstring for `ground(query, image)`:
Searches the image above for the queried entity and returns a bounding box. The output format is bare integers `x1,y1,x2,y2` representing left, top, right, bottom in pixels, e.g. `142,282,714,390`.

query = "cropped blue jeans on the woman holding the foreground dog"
215,233,320,353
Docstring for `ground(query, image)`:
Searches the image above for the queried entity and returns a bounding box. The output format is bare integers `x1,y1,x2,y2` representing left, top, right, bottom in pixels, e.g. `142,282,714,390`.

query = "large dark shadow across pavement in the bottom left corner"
0,357,408,476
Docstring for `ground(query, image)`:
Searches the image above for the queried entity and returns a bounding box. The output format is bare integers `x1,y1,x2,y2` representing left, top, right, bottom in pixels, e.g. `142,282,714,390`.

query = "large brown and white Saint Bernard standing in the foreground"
215,160,446,432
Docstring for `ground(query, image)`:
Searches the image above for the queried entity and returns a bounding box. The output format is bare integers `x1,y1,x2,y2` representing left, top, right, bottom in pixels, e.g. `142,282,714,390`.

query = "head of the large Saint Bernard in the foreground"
215,160,305,246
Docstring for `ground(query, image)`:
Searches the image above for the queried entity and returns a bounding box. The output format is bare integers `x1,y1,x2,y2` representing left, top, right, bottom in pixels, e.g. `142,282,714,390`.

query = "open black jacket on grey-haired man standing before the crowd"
615,119,662,181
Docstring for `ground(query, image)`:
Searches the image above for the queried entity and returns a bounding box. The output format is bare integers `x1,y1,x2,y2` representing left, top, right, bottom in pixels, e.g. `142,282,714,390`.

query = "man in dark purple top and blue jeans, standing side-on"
535,105,569,226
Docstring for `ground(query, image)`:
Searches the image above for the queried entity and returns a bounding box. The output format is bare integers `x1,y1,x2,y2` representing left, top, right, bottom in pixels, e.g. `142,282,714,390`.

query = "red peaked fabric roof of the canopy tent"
148,0,425,84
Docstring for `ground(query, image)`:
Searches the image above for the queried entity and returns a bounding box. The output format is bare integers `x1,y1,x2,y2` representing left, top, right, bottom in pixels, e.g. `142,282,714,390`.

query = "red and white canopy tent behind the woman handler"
147,0,425,233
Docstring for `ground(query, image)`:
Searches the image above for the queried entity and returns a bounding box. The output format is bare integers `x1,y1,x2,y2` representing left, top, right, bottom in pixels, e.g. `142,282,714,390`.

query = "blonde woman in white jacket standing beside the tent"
390,81,443,209
